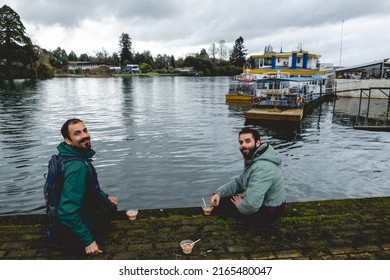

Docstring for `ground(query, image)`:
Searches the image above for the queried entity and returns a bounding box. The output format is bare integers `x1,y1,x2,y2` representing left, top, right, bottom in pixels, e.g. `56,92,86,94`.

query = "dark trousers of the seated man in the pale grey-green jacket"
213,197,286,228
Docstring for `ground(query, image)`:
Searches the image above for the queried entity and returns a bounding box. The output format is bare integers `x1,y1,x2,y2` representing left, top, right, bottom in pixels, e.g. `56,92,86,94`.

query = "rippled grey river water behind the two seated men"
0,77,390,215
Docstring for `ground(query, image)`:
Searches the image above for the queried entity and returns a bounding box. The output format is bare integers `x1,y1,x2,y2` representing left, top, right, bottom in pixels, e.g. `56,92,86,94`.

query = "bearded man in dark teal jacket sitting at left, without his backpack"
57,119,118,255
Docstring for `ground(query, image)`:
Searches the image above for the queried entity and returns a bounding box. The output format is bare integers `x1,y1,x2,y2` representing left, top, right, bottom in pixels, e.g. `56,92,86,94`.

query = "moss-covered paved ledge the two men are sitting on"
0,197,390,260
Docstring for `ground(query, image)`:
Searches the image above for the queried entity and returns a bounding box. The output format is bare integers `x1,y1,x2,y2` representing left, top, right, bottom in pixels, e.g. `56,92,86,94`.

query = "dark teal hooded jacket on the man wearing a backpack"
57,142,107,247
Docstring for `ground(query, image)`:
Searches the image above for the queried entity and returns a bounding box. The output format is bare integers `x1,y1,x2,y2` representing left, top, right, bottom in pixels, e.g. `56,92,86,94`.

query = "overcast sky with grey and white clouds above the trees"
4,0,390,66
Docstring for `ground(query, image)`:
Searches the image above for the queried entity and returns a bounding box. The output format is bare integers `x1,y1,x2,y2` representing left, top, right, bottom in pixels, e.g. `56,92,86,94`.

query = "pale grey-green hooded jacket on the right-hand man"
216,143,286,215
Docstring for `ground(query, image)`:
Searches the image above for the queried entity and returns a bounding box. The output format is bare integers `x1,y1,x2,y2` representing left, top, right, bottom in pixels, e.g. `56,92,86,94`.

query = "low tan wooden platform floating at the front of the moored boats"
245,108,303,122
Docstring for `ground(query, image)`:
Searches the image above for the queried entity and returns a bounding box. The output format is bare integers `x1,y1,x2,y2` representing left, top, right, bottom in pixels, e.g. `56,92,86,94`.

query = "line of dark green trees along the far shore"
0,5,247,80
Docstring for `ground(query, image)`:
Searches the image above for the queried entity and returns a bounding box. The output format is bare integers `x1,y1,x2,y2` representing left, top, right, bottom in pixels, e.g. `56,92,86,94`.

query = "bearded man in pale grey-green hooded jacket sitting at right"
210,128,286,228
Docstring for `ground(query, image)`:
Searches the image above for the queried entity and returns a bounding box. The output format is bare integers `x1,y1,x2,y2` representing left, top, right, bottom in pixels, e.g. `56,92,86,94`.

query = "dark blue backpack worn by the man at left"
43,155,84,237
